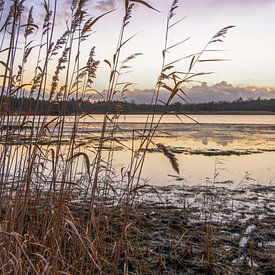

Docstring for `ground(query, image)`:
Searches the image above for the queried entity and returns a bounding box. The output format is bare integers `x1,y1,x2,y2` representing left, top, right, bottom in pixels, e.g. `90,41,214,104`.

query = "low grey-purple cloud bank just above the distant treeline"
89,81,275,103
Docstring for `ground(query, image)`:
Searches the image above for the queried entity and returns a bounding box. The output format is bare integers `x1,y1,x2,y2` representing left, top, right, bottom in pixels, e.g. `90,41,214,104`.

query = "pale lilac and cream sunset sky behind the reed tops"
0,0,275,101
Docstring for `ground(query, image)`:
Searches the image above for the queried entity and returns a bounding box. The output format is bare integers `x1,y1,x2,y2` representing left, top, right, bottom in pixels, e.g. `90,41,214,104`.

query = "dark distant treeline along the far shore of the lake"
0,97,275,115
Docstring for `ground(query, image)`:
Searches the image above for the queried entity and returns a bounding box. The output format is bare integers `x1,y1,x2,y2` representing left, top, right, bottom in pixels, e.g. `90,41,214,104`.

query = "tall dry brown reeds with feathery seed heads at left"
0,0,239,274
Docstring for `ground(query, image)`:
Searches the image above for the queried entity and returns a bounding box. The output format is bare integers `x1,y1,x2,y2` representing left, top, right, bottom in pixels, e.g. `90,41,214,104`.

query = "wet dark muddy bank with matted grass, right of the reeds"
87,186,275,274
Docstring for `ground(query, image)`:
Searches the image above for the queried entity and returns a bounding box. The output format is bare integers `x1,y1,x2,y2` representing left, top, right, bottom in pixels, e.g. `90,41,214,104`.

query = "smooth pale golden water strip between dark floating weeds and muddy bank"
116,151,275,187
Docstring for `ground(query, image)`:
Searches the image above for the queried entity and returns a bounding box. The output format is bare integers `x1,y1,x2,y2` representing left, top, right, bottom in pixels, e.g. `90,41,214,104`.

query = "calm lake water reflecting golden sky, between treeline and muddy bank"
1,115,275,187
